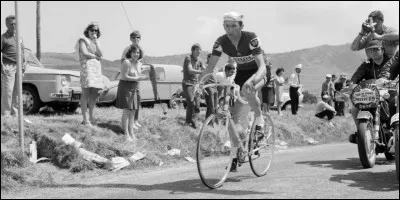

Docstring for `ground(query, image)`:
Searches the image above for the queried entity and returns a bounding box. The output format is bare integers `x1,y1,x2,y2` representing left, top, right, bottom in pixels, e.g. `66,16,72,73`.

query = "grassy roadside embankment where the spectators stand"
1,105,355,189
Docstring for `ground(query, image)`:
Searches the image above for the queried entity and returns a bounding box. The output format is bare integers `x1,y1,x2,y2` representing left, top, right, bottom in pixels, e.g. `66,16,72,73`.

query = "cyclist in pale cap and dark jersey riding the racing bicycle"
201,11,270,171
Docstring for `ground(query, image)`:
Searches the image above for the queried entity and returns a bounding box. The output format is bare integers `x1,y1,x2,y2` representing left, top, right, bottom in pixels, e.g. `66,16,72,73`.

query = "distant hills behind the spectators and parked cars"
42,44,366,96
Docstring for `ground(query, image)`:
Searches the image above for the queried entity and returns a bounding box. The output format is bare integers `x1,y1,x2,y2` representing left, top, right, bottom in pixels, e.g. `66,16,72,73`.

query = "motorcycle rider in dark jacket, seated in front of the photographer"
349,40,390,144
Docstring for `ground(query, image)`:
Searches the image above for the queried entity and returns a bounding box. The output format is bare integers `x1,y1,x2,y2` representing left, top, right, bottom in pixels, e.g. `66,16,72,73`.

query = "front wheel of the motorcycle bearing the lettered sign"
357,121,376,168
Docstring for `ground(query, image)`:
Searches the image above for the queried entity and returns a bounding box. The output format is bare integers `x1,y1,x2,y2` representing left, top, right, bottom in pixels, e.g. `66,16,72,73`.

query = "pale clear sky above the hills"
1,1,399,60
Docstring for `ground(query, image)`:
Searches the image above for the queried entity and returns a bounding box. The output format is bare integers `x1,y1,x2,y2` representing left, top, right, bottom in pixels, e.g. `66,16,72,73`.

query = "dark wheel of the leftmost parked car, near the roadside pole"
22,85,41,114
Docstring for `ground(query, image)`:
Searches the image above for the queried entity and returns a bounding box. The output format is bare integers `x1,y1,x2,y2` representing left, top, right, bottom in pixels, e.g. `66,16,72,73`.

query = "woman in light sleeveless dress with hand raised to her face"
75,22,104,126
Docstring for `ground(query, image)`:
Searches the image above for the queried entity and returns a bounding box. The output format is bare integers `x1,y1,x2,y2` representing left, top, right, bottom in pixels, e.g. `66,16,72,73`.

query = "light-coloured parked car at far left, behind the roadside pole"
22,49,82,114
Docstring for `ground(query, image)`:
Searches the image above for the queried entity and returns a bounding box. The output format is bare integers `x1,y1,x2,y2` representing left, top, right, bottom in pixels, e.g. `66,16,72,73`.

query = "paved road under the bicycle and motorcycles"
2,144,399,199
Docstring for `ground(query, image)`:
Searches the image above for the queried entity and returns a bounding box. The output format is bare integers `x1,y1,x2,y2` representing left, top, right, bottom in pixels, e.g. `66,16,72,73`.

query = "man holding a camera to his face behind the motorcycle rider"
351,10,399,58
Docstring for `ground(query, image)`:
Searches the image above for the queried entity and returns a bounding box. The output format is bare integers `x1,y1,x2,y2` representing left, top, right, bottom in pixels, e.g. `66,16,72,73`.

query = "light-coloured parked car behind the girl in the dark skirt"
98,64,183,108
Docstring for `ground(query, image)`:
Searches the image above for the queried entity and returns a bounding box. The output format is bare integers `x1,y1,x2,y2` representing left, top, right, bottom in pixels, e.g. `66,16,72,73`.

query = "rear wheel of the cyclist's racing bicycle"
249,112,276,177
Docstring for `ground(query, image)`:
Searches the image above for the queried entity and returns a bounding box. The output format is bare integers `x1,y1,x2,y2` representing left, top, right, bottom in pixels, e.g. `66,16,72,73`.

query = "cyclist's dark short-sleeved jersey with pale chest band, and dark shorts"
212,31,263,87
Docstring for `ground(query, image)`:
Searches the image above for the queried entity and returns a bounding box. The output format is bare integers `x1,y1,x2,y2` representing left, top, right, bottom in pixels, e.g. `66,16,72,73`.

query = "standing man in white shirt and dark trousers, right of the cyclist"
289,64,302,115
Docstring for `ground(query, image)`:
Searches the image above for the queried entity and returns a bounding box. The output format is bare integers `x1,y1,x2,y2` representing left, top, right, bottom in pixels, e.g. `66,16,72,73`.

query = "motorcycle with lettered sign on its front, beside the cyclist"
350,79,398,168
